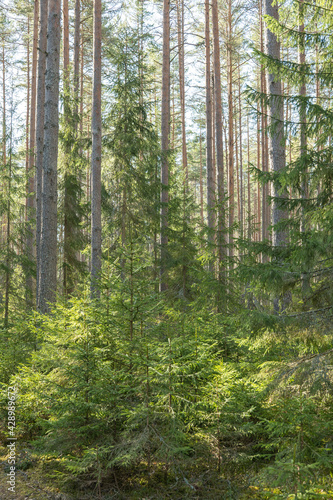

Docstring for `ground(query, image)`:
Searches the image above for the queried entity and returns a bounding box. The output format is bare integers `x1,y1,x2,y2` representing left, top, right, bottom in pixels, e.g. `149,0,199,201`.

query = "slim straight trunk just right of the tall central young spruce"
160,0,170,292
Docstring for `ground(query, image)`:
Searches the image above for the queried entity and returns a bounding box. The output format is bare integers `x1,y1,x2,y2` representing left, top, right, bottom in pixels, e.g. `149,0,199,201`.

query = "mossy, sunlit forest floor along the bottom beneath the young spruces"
0,446,267,500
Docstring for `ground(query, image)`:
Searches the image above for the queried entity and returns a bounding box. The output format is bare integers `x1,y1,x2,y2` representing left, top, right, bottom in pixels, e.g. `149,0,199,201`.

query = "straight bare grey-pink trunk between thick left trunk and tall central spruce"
91,0,102,298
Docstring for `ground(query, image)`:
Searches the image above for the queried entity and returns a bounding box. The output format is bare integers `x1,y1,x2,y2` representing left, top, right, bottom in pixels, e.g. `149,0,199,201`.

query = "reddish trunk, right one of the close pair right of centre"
212,0,226,281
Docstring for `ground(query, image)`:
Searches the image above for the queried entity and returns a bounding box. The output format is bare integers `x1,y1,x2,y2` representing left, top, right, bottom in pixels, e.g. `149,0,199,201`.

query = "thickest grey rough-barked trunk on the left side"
39,0,61,313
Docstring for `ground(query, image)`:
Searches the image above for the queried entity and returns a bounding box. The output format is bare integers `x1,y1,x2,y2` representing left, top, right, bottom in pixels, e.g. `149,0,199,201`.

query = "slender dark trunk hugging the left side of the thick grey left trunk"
36,0,48,305
